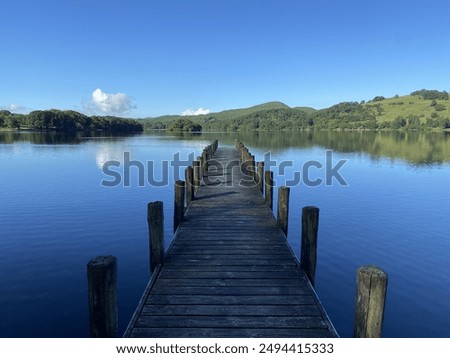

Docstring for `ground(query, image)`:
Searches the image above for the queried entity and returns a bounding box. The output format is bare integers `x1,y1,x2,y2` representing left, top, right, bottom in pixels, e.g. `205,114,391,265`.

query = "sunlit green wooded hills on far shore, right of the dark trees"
143,89,450,131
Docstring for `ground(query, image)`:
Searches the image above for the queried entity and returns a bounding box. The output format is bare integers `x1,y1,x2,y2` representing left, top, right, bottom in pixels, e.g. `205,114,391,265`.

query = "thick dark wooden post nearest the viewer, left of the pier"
87,256,118,338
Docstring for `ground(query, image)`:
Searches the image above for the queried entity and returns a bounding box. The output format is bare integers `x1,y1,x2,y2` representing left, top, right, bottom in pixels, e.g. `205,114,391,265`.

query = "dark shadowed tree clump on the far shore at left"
0,109,143,133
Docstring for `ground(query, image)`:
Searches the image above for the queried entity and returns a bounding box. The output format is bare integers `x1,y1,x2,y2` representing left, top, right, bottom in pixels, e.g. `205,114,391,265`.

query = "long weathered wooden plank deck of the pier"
124,144,337,337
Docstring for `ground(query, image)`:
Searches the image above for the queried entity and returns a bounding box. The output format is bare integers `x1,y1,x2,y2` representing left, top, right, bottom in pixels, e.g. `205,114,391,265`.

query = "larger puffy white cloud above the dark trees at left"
85,88,136,116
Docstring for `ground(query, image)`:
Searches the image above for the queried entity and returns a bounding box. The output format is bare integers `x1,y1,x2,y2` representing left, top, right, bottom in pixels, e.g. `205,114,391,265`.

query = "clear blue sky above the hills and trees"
0,0,450,117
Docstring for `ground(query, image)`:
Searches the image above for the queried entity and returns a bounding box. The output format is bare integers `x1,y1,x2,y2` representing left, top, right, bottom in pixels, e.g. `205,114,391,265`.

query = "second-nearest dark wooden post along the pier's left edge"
147,201,165,273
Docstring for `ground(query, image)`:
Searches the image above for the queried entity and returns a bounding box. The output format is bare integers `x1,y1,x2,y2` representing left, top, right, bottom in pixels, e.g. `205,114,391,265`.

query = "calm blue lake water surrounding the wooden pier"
0,132,450,337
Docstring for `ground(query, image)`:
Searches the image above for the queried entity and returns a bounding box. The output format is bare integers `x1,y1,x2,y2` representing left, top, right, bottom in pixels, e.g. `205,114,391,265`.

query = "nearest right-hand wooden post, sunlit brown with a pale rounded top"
353,266,388,338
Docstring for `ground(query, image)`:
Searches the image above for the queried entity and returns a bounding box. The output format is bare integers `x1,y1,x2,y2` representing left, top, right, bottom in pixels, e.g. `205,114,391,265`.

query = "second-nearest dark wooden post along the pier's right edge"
300,206,319,286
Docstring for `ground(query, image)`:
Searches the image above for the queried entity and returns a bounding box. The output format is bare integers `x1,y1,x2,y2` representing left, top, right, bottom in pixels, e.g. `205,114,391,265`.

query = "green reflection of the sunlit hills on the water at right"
148,131,450,166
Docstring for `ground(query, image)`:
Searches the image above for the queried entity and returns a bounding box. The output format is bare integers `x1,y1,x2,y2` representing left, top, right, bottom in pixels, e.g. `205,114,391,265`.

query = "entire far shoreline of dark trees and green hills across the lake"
0,89,450,133
